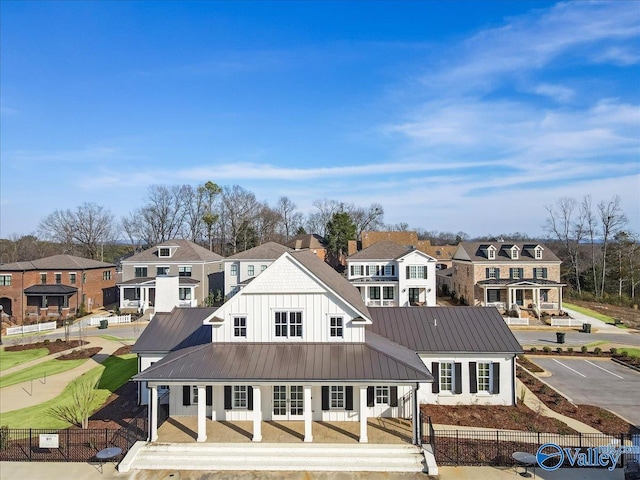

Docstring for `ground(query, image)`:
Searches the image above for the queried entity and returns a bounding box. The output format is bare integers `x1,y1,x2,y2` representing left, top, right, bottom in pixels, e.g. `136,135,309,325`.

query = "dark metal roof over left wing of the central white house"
131,308,217,353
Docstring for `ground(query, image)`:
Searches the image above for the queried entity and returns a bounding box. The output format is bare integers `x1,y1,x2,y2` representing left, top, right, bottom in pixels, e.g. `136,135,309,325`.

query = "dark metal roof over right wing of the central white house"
367,307,522,353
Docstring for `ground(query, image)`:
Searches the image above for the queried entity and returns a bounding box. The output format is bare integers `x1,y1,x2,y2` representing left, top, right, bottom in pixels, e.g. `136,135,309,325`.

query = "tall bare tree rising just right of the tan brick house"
544,197,587,293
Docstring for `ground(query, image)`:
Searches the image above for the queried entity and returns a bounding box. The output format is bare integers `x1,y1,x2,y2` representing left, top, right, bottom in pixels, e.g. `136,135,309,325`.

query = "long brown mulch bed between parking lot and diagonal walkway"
516,368,636,434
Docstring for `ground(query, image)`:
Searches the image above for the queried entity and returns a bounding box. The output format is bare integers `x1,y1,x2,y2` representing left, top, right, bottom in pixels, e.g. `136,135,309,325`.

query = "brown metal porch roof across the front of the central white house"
133,336,433,383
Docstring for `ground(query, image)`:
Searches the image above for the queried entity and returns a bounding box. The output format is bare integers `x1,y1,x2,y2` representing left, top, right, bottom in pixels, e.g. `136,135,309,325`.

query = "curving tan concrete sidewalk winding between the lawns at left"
0,337,130,413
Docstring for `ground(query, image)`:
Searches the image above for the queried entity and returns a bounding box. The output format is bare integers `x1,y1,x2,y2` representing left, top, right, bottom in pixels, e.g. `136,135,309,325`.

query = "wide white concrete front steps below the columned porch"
118,442,425,472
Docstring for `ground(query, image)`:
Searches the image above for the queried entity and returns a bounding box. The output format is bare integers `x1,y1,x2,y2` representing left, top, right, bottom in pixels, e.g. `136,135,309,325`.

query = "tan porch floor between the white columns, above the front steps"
158,416,412,444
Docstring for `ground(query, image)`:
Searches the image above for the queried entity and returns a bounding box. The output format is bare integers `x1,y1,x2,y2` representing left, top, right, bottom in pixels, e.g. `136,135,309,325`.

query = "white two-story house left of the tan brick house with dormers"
347,241,437,307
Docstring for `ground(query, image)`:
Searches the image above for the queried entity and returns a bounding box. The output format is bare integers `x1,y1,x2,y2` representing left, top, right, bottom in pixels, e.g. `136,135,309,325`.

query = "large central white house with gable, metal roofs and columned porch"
133,251,522,442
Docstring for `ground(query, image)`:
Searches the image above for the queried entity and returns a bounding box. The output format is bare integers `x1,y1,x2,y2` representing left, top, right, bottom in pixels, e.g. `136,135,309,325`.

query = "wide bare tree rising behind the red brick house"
38,202,115,259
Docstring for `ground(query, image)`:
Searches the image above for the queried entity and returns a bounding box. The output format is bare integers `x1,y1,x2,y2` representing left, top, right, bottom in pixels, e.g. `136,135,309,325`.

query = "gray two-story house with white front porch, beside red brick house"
118,239,224,313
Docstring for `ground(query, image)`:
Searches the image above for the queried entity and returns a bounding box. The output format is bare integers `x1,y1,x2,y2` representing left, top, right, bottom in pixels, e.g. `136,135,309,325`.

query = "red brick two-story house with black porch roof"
0,255,116,323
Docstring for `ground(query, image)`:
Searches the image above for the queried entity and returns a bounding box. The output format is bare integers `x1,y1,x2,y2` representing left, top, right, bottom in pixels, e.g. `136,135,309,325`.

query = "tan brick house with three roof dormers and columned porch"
451,241,564,316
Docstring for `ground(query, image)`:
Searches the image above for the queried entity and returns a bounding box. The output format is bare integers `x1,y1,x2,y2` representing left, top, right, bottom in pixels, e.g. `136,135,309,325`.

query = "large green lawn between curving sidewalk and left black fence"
0,354,138,429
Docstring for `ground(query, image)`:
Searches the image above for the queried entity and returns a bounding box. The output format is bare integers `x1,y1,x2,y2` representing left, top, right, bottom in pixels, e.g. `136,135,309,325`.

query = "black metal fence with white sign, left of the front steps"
0,414,147,462
